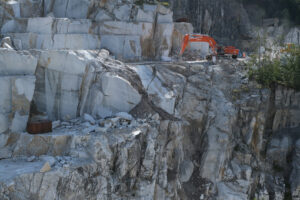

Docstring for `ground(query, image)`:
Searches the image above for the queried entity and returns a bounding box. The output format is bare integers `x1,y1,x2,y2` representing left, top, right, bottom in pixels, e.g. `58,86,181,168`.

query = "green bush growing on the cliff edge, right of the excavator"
249,46,300,90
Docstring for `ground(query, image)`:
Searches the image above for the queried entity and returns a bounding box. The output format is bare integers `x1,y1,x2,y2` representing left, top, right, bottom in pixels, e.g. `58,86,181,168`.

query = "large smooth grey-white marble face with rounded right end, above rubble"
34,50,141,120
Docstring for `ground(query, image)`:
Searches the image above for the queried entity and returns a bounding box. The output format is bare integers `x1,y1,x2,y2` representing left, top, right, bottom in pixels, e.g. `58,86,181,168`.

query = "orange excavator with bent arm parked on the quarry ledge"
179,34,246,59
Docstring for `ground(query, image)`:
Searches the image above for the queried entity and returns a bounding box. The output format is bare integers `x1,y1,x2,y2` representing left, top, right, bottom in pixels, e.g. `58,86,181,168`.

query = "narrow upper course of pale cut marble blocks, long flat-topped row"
1,17,153,37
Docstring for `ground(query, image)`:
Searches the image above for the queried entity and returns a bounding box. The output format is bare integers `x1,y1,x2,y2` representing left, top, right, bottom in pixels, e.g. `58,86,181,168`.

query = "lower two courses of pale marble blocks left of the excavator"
1,17,174,61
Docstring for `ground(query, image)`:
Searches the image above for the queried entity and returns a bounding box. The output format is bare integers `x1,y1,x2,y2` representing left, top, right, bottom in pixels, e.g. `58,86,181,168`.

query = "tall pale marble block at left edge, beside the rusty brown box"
0,49,37,134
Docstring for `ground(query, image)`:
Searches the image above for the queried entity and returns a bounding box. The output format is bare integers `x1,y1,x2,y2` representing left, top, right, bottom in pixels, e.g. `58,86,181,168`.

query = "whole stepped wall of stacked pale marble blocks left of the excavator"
1,0,183,61
